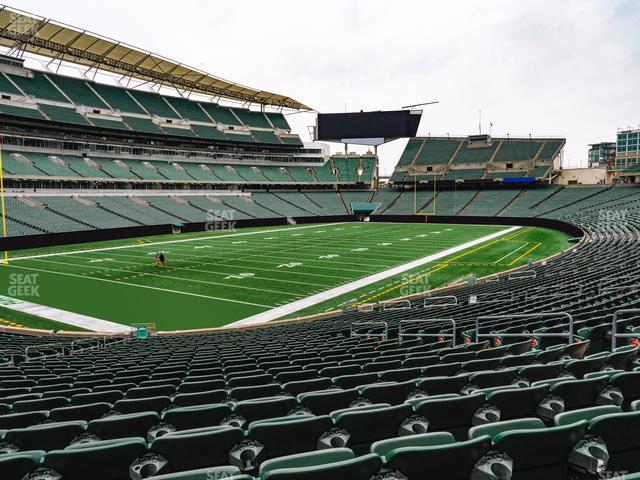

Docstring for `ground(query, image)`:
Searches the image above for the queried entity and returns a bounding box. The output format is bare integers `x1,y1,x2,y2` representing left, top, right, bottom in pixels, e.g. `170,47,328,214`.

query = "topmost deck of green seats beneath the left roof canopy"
0,71,302,152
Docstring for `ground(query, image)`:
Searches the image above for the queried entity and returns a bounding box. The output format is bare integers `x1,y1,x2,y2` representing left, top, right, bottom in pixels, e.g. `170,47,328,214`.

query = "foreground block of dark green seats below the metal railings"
0,324,640,480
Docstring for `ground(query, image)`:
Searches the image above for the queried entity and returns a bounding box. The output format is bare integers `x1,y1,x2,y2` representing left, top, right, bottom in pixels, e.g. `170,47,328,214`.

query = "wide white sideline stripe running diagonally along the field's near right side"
229,226,522,326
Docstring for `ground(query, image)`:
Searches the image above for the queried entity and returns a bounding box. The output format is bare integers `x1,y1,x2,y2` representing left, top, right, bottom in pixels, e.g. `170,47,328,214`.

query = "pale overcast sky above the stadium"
10,0,640,174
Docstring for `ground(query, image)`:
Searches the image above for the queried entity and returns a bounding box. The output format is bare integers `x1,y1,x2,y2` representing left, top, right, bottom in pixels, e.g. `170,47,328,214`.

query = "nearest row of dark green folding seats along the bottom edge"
5,407,640,480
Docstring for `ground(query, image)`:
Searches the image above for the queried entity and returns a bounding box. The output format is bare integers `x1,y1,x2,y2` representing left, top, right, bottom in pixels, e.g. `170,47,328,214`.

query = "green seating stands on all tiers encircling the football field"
0,25,640,480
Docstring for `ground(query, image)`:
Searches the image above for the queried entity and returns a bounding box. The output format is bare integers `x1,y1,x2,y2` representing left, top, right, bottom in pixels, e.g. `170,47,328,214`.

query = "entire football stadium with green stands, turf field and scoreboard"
0,2,640,480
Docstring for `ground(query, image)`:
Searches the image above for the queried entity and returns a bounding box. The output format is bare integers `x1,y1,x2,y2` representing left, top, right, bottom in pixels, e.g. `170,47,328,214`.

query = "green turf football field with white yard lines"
0,223,569,330
